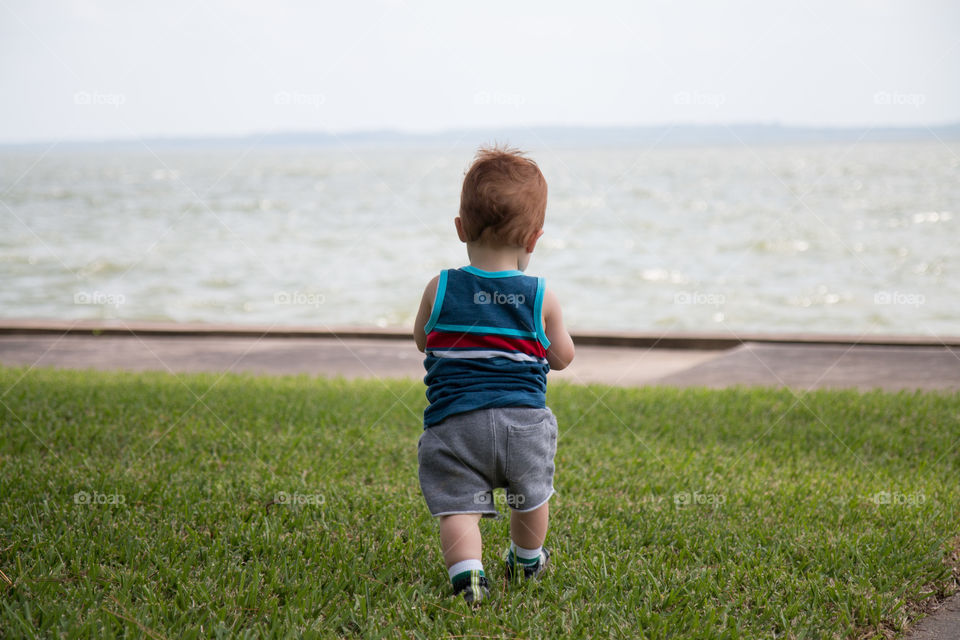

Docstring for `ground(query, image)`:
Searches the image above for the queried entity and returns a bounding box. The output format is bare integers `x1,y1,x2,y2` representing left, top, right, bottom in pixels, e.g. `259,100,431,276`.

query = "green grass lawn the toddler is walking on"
0,368,960,638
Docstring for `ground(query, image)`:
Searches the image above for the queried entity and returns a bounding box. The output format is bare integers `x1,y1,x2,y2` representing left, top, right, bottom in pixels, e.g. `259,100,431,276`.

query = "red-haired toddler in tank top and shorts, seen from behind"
414,147,574,604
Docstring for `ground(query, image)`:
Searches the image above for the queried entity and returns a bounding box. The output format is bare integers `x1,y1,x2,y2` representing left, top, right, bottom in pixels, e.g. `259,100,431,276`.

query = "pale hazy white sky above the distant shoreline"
0,0,960,142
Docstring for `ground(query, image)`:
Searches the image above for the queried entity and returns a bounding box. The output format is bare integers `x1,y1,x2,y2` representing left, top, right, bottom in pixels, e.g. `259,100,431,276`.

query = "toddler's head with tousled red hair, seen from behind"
459,147,547,251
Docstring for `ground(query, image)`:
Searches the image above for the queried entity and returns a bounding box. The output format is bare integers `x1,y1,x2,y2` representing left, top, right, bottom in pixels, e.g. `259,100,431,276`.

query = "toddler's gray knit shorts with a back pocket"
417,407,557,518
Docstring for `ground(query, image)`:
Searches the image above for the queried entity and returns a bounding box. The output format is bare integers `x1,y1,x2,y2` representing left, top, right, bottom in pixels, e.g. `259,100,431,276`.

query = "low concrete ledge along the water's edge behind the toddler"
0,319,960,350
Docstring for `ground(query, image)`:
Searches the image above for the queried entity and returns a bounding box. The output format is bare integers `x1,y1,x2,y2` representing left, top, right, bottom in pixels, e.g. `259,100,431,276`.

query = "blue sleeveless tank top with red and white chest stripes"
423,266,550,428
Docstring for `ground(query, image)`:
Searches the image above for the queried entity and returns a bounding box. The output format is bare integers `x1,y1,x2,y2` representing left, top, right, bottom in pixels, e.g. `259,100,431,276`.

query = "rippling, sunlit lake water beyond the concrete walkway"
0,142,960,335
